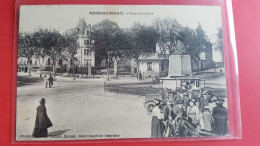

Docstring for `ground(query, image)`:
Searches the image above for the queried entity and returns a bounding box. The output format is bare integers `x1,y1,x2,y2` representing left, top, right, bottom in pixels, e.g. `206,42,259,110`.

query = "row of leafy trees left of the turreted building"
18,28,78,78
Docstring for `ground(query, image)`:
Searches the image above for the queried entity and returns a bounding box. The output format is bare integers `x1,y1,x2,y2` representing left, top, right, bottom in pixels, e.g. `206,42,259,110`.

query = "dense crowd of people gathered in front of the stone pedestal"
151,91,228,137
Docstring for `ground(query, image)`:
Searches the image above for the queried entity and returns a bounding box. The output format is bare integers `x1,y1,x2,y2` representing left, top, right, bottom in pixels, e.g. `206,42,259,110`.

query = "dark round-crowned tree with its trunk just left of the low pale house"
126,23,158,79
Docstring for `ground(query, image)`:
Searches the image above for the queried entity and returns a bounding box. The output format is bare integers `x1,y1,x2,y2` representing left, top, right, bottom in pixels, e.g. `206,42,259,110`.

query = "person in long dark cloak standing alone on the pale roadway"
32,98,52,137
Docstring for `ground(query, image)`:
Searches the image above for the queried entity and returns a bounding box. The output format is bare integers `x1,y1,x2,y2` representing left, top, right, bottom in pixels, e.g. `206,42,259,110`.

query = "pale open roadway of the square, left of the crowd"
16,78,151,140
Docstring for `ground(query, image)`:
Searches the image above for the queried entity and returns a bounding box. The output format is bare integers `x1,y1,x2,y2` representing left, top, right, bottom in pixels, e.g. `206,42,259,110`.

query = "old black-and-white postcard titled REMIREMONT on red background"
15,5,230,141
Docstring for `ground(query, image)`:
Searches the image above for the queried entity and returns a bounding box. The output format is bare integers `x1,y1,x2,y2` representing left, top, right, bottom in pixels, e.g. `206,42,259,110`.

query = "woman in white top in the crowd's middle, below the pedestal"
187,99,199,125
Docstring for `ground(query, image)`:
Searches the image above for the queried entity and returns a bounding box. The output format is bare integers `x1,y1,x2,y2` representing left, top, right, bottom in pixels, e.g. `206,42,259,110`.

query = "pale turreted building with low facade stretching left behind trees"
17,18,95,70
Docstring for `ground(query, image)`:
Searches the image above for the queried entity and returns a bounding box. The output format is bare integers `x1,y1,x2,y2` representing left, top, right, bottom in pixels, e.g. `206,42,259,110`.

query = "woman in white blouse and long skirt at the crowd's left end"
151,99,164,137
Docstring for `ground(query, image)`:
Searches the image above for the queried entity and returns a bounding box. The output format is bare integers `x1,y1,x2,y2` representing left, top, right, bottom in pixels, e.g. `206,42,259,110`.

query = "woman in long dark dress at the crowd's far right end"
212,98,228,136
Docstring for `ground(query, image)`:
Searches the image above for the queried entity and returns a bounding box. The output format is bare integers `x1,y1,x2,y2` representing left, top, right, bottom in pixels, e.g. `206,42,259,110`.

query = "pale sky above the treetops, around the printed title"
19,5,222,61
